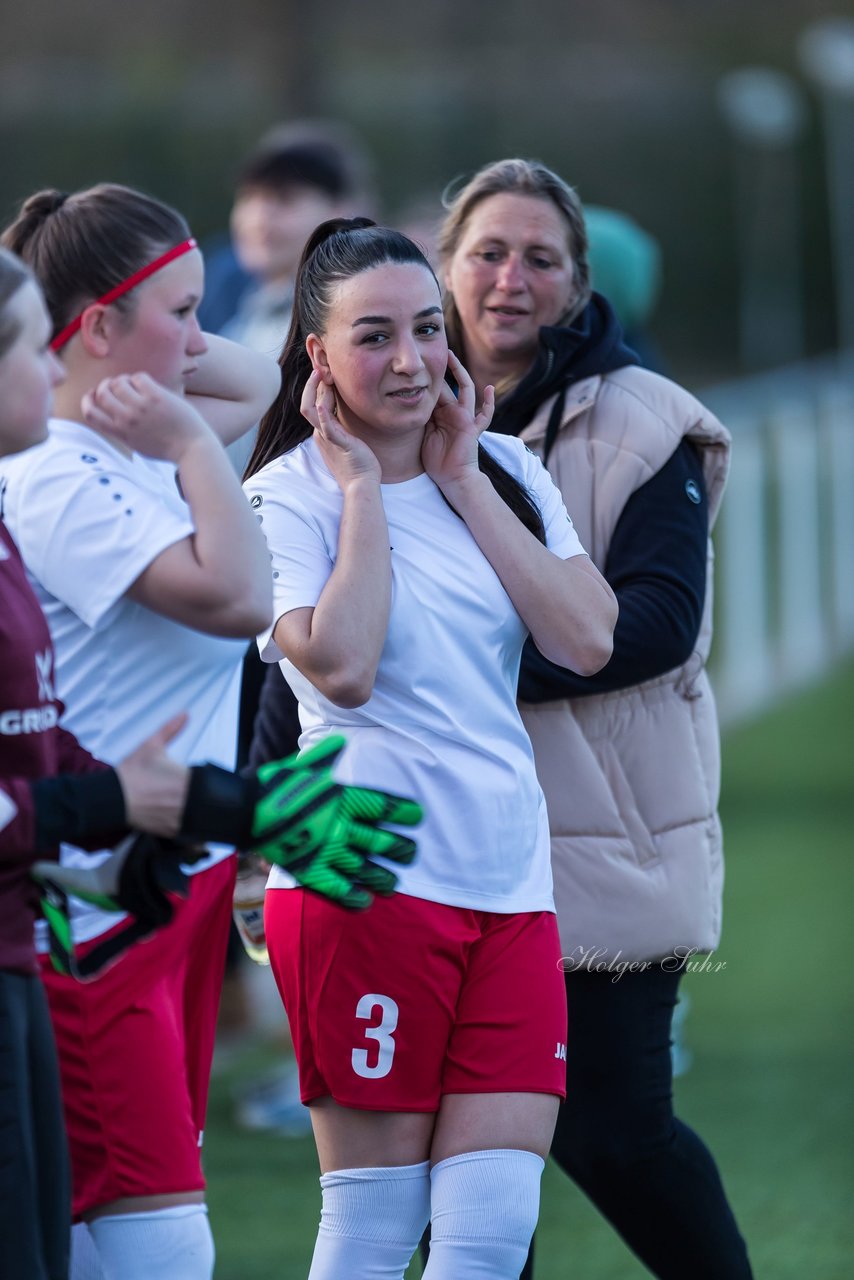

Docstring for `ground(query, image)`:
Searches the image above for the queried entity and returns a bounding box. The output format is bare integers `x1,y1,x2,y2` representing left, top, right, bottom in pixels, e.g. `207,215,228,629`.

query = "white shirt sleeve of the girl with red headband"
15,447,193,627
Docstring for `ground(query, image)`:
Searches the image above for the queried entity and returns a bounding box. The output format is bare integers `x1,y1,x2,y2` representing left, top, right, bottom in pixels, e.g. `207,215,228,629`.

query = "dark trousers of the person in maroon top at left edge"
0,972,72,1280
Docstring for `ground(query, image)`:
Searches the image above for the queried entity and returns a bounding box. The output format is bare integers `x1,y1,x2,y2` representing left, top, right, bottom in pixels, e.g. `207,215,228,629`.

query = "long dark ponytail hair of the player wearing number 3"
245,218,545,541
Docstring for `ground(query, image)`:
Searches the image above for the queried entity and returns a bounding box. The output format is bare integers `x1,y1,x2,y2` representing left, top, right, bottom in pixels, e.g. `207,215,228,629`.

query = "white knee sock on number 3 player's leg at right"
424,1151,545,1280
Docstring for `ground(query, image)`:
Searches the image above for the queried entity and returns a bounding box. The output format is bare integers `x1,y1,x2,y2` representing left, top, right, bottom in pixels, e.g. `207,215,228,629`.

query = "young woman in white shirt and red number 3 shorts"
245,219,616,1280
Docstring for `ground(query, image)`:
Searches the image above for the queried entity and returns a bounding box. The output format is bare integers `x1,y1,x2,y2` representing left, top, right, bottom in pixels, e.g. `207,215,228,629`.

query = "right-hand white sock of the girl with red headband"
88,1204,214,1280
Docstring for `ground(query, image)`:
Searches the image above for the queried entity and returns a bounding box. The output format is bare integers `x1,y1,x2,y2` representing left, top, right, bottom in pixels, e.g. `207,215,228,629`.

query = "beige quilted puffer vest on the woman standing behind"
520,367,730,969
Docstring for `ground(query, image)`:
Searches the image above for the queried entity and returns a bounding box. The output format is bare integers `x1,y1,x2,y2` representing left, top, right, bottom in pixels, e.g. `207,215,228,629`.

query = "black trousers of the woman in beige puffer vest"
537,965,752,1280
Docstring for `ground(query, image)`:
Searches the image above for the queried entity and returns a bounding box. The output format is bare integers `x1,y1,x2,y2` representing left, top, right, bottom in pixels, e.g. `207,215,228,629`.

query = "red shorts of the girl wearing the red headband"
42,858,236,1220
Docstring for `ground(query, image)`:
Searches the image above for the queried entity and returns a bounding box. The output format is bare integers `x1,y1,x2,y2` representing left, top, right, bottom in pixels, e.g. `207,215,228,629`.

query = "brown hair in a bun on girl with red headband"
0,183,189,345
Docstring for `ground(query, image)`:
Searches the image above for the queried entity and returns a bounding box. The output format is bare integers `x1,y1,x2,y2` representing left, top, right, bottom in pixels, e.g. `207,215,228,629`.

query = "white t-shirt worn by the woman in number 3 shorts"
245,434,584,911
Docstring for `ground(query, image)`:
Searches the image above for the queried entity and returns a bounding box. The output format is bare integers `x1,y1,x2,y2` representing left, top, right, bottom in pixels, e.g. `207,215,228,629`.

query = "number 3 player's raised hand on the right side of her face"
421,351,495,493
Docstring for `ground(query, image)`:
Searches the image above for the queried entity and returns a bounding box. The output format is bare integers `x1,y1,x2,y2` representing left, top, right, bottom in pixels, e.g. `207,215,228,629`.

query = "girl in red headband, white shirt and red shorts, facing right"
3,186,279,1280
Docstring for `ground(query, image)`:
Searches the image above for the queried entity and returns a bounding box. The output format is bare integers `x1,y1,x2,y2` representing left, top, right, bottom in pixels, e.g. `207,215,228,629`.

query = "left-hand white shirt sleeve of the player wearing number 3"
245,479,335,662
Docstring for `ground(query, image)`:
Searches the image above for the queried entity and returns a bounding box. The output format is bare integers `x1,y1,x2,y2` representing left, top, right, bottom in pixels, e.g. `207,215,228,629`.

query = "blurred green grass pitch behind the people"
205,663,854,1280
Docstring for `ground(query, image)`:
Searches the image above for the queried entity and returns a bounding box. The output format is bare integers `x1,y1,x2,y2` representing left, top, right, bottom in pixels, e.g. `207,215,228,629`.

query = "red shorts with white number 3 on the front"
265,890,566,1111
